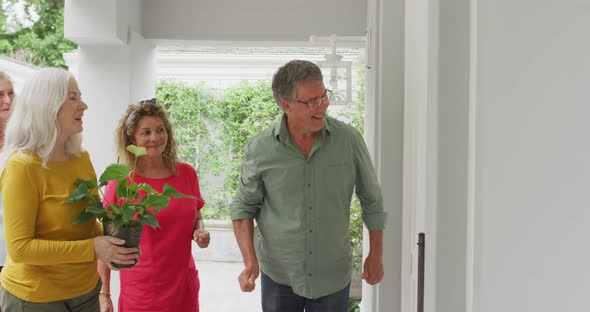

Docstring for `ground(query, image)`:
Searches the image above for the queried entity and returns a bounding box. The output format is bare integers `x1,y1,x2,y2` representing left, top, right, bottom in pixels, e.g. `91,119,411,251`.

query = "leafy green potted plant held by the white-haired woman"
65,145,192,268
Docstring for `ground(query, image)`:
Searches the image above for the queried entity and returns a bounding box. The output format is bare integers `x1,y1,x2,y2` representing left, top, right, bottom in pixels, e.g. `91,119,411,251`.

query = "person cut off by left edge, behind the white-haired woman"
0,71,14,271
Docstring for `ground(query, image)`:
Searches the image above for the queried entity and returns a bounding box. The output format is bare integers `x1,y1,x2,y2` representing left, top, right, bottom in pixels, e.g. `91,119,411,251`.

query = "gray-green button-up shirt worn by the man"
230,115,385,299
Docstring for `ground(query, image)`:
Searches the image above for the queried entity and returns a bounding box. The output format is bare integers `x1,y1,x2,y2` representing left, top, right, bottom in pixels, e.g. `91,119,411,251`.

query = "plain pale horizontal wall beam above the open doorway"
143,0,367,41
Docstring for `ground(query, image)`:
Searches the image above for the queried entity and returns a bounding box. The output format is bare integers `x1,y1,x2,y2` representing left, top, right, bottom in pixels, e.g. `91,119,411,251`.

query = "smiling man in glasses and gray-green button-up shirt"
230,60,385,312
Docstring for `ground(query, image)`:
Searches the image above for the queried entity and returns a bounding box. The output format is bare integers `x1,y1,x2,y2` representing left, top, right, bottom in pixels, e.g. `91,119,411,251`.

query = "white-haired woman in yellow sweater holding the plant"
0,68,138,312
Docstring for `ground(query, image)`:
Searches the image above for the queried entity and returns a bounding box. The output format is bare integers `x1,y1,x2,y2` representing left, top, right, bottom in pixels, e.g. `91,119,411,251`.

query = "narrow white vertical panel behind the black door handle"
401,0,438,311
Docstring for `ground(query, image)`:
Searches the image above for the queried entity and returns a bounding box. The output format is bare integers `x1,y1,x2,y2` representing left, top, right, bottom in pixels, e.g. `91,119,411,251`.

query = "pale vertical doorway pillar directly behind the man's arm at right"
361,0,407,312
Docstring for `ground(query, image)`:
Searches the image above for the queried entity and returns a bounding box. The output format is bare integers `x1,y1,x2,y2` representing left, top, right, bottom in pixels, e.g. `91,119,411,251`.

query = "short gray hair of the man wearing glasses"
272,60,324,109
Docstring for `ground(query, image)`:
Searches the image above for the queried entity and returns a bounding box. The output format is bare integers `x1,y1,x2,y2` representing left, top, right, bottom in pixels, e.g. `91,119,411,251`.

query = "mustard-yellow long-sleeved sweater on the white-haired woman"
0,152,100,302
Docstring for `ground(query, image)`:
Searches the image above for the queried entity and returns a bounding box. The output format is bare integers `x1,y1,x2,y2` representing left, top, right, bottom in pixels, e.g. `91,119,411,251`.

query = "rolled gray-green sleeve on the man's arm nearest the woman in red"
230,145,263,220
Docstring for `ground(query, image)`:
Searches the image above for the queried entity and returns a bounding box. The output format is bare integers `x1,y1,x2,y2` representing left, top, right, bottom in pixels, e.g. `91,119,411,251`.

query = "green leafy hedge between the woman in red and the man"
156,80,281,219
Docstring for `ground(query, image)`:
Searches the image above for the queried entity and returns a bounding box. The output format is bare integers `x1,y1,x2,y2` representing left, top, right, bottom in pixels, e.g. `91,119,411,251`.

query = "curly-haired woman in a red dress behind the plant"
99,99,209,312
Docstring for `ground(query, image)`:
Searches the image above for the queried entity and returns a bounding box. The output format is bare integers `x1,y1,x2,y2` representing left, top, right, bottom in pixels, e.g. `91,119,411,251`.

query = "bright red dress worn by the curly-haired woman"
105,163,205,312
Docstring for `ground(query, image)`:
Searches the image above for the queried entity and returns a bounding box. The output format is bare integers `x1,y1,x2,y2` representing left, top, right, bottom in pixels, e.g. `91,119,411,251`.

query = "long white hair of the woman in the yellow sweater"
0,68,82,167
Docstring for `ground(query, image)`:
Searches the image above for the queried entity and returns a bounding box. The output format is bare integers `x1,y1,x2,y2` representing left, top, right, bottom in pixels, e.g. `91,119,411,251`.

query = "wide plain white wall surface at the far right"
472,0,590,312
